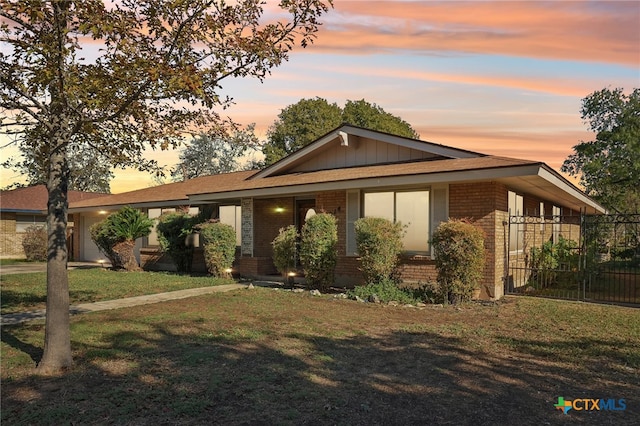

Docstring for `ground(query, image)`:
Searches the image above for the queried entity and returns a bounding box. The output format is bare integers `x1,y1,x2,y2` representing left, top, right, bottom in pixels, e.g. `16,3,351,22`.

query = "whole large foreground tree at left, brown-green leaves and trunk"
0,0,331,372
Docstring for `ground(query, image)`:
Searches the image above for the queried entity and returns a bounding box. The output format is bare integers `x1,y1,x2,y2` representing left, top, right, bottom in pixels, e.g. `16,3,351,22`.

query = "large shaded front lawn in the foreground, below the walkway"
0,288,640,425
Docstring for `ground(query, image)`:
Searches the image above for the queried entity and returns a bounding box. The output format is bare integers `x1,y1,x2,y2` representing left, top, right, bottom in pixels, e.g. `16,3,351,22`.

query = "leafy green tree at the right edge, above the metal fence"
562,88,640,213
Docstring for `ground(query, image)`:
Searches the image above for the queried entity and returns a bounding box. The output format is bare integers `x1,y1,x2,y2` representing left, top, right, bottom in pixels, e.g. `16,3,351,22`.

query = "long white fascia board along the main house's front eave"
189,164,539,203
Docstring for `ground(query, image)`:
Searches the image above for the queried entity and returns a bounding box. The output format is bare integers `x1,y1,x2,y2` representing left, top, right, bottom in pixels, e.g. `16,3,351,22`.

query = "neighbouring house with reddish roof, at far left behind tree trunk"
0,185,107,259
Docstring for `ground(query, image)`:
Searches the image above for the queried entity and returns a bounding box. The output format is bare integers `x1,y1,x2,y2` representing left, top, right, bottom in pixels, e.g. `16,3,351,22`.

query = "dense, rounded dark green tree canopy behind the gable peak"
262,97,420,165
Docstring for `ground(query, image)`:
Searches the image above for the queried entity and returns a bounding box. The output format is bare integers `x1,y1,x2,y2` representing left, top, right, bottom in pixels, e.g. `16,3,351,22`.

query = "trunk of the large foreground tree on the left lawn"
38,149,73,374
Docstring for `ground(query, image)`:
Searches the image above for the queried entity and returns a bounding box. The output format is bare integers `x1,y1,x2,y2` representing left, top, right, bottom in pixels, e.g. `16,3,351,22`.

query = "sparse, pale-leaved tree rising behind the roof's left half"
171,124,258,182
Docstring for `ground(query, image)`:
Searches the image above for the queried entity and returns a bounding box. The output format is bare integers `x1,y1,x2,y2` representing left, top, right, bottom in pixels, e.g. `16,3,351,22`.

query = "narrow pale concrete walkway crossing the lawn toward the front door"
0,284,248,325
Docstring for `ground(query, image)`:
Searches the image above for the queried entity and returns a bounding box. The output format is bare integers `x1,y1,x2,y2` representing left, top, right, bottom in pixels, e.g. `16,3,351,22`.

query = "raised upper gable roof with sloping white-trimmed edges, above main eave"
251,124,485,179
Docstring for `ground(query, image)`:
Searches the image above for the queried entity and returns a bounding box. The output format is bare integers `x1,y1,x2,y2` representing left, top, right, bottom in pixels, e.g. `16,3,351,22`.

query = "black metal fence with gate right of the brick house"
505,214,640,304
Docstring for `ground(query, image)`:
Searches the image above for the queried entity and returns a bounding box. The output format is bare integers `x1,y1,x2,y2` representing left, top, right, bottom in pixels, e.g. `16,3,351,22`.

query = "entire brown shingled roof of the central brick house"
70,125,605,212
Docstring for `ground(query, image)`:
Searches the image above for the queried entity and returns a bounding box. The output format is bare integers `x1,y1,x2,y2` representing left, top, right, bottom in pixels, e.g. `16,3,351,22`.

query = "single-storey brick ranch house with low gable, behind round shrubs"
70,125,604,298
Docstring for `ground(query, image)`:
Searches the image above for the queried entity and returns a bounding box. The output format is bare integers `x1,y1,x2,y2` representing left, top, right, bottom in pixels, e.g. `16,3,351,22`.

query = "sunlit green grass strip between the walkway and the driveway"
0,268,233,314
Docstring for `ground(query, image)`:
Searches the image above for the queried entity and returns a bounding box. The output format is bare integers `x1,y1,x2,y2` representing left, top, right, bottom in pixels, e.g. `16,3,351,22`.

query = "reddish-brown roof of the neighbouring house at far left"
0,185,108,214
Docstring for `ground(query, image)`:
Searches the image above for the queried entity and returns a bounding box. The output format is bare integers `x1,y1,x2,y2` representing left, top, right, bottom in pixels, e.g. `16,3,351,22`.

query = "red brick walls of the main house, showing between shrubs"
141,182,575,299
